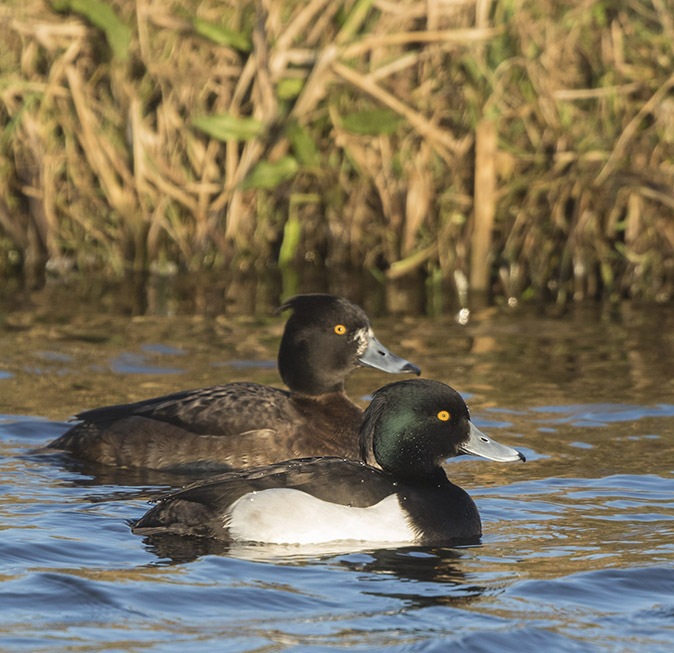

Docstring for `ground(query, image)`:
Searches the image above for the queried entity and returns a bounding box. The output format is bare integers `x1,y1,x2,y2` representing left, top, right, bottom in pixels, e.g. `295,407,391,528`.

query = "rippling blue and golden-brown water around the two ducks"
0,282,674,653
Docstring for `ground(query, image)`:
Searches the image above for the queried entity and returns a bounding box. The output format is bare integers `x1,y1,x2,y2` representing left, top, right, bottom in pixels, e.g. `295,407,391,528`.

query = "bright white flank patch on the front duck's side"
225,488,415,544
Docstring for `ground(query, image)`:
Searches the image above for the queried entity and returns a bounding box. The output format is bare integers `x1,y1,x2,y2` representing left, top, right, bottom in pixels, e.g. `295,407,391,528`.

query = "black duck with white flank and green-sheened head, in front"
132,379,525,546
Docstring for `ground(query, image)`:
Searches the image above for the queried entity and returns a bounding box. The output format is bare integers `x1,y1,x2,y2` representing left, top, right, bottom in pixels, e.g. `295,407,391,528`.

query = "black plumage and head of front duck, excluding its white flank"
133,380,524,544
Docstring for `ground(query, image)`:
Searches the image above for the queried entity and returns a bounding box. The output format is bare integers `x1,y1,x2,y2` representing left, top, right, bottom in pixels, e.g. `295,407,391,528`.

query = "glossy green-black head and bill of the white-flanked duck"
361,379,525,482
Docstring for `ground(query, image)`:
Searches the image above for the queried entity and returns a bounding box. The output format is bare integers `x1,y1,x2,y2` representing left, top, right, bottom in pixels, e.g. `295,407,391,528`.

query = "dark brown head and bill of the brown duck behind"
278,294,420,395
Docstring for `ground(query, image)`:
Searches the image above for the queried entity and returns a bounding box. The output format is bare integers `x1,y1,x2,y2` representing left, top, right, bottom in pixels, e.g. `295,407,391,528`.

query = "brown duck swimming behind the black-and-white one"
44,294,421,474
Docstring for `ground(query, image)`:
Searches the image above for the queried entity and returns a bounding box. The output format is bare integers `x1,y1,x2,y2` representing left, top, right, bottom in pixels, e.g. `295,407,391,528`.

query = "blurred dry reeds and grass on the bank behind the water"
0,0,674,303
